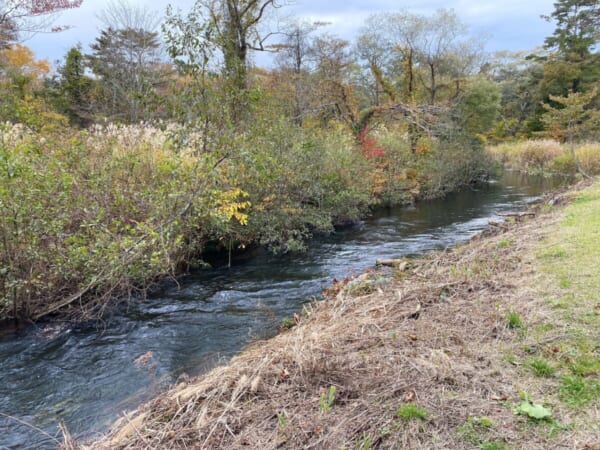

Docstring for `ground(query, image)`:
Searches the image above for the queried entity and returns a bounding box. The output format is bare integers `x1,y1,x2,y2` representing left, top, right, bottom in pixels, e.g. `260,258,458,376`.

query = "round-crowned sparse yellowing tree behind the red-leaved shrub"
357,9,481,153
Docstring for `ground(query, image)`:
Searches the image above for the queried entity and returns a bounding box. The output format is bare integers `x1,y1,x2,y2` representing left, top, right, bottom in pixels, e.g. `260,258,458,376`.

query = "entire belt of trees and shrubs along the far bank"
0,0,599,319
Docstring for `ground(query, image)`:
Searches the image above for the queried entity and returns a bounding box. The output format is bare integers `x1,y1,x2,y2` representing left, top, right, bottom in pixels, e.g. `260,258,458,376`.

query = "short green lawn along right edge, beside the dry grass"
527,182,600,412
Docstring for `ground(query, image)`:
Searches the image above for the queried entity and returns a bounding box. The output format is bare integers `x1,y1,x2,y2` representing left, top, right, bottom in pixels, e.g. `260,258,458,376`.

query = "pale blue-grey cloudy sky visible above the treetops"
25,0,553,67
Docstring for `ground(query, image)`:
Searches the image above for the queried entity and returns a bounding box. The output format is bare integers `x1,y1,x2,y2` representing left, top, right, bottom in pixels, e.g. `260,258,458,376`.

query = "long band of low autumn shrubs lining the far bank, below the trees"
0,118,486,321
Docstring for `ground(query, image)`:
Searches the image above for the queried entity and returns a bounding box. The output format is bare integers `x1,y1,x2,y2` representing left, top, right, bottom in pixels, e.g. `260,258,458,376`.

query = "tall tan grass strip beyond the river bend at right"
487,139,600,176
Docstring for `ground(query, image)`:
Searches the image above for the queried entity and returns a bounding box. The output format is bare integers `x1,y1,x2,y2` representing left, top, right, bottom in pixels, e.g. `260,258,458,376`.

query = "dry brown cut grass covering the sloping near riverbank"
76,180,600,450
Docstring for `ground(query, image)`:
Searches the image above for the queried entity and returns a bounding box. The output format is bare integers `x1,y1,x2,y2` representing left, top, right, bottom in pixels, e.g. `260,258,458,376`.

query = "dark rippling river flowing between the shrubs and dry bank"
0,173,556,450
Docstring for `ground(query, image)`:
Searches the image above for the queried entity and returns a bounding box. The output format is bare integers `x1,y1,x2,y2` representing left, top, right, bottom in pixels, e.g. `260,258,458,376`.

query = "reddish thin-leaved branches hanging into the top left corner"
0,0,83,47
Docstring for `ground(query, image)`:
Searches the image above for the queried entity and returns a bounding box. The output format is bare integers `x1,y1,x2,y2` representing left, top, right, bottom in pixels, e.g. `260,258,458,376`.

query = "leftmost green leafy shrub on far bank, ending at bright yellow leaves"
0,125,245,318
